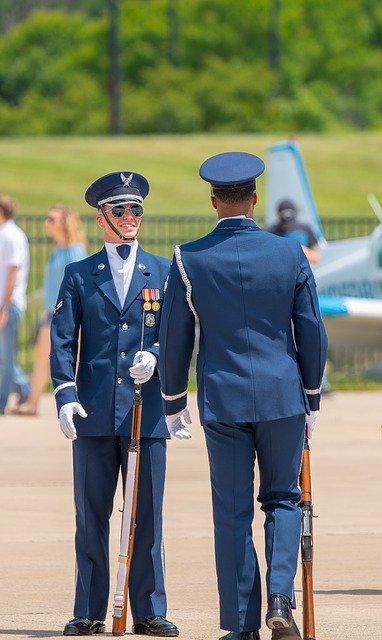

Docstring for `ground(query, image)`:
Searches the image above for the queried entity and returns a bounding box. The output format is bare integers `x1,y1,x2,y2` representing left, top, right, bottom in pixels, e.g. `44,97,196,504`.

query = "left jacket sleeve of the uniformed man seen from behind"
159,258,195,415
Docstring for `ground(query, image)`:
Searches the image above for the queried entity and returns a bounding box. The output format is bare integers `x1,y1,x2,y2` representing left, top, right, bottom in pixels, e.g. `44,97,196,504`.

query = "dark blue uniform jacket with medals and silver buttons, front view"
50,247,170,438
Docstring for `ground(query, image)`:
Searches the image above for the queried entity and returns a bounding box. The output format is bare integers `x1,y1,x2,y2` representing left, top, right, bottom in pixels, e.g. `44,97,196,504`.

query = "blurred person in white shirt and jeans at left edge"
0,195,29,415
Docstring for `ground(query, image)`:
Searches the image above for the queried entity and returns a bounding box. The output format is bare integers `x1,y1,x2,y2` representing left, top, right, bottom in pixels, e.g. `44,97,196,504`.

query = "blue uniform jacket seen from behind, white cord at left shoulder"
160,218,327,424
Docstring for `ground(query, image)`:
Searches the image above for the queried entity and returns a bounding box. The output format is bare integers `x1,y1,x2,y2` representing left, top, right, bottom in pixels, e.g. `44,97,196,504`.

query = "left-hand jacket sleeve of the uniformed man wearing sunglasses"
50,267,82,412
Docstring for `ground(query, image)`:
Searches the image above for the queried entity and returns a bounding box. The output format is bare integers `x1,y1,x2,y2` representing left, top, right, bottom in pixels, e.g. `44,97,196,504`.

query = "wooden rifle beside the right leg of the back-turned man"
300,436,316,640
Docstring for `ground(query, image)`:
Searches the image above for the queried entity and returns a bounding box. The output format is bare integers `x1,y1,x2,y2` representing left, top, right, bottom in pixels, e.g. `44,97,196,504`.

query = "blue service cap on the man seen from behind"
199,151,265,189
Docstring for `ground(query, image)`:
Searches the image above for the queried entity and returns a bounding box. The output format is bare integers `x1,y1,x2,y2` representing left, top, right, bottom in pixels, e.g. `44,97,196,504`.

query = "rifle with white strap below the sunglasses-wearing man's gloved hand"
112,384,142,636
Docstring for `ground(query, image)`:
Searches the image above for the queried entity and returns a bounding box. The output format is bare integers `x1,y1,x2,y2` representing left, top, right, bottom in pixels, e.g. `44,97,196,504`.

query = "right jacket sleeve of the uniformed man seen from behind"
292,249,328,411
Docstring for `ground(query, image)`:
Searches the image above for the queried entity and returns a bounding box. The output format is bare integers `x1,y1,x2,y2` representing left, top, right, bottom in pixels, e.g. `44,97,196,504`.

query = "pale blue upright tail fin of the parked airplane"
265,140,325,244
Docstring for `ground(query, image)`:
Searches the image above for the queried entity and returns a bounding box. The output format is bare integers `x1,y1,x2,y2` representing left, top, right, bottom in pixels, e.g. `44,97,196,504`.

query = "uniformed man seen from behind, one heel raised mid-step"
159,152,327,640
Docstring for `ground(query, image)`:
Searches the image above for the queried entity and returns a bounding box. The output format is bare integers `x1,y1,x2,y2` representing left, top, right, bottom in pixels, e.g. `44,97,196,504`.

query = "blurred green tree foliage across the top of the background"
0,0,382,135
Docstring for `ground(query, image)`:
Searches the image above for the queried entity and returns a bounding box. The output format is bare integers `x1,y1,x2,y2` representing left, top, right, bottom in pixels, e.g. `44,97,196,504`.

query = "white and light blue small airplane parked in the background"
265,140,382,364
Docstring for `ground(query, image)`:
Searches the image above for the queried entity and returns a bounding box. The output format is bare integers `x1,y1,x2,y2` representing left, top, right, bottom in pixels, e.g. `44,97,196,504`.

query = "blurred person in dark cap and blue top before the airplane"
267,200,320,264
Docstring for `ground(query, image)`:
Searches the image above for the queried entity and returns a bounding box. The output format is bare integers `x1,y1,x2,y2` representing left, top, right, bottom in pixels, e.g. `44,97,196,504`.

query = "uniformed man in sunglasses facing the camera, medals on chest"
50,171,179,636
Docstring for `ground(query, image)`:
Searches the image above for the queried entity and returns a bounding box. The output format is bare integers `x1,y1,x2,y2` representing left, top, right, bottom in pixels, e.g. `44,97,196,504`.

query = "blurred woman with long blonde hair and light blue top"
12,204,87,415
